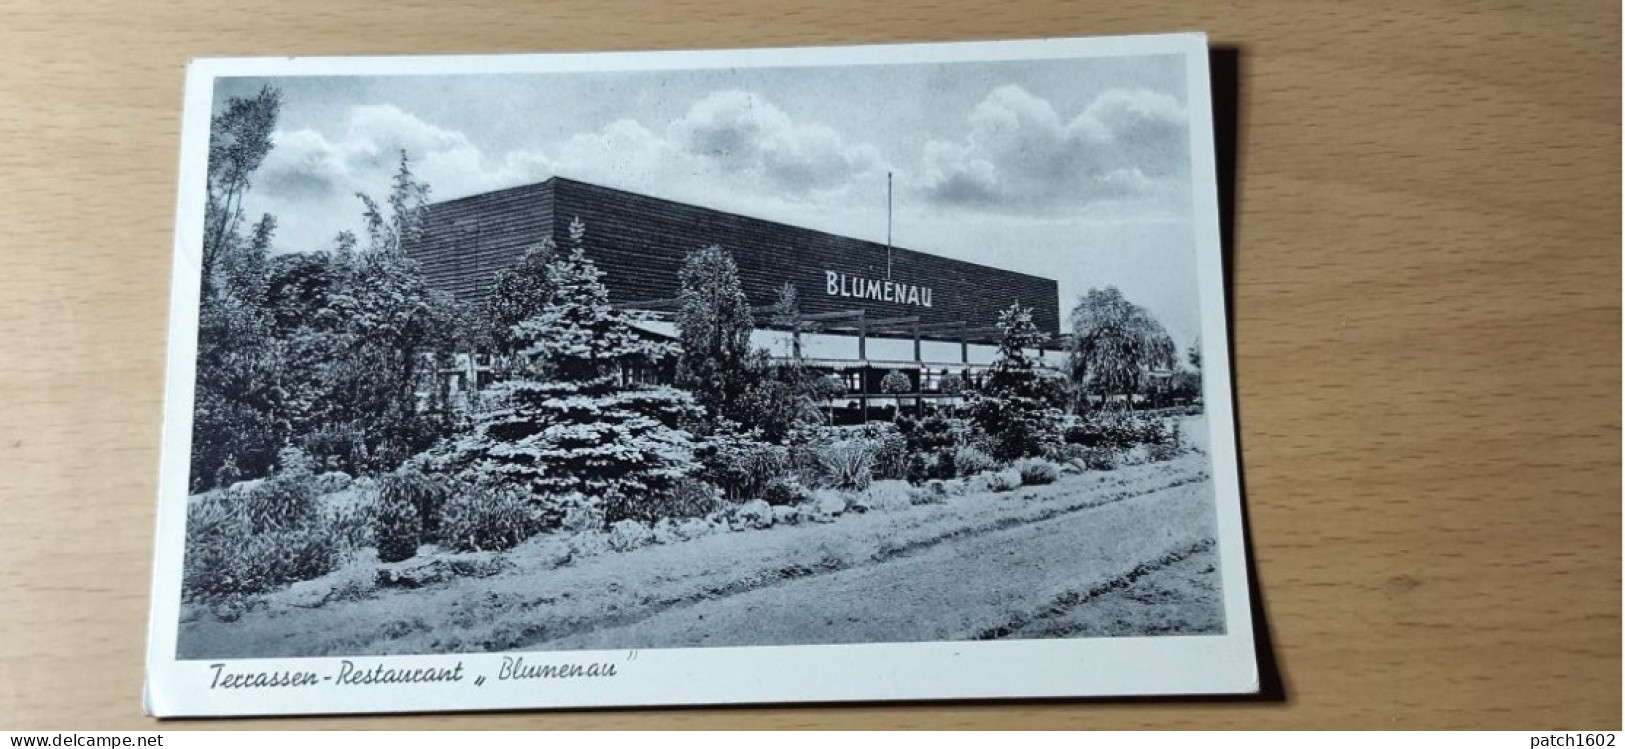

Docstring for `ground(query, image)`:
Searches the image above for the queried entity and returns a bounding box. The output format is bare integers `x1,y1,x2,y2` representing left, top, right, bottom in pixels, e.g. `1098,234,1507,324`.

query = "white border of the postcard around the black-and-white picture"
146,34,1258,717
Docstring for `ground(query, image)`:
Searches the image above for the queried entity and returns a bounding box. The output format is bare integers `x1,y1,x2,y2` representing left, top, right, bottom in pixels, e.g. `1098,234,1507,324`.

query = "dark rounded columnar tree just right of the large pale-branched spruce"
678,245,759,421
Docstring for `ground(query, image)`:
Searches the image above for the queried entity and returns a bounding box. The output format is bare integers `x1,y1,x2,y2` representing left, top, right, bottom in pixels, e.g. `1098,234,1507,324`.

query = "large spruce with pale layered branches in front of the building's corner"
429,219,700,525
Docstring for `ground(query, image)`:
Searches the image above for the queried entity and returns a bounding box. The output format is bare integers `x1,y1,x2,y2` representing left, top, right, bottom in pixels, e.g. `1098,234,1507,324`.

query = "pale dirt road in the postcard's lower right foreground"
528,481,1212,650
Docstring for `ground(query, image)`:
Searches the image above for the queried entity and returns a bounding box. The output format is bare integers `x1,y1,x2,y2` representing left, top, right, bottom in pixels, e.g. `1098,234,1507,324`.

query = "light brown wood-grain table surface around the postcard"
0,0,1620,730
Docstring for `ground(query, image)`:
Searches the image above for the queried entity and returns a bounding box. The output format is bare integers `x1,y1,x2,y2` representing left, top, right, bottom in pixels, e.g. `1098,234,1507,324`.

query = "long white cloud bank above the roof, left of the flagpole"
247,91,889,250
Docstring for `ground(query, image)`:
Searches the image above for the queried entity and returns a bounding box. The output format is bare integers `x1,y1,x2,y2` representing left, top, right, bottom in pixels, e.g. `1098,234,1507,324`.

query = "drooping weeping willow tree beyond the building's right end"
1071,286,1177,408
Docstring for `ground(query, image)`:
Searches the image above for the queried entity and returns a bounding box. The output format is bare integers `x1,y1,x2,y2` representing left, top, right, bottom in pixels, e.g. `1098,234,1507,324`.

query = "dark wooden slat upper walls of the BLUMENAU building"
410,177,1060,331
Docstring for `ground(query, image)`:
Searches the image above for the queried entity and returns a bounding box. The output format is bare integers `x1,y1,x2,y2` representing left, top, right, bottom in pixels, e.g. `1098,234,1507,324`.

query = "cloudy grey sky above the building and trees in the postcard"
215,55,1199,348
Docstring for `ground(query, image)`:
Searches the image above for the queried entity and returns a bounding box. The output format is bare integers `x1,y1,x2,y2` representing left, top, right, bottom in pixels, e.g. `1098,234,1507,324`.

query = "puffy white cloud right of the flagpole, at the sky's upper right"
915,86,1190,214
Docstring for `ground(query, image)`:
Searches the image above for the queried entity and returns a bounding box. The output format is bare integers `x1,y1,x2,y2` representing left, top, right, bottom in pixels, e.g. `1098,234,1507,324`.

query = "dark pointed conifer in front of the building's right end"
970,304,1061,460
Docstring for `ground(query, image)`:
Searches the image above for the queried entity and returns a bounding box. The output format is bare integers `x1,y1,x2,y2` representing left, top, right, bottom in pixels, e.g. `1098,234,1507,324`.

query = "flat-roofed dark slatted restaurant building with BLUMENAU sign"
406,177,1061,419
